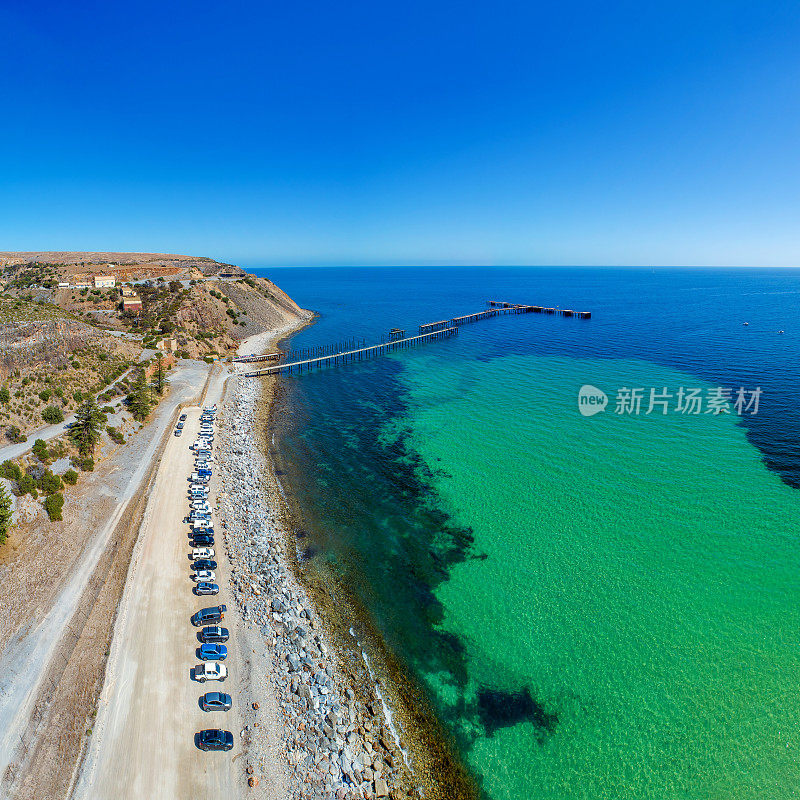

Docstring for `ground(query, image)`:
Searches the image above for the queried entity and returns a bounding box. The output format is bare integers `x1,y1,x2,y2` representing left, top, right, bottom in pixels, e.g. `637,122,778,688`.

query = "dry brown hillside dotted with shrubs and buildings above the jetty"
0,252,310,439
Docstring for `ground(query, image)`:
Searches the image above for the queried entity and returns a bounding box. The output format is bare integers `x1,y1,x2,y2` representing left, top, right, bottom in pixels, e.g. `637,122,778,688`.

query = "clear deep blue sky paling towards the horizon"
0,0,800,266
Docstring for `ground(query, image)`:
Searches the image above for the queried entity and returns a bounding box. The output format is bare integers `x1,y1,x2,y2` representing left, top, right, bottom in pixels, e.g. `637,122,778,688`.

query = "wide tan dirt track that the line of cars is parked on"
72,376,250,800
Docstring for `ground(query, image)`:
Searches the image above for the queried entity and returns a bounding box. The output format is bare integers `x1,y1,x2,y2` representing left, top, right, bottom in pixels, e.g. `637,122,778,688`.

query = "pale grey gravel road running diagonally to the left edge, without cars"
0,366,207,789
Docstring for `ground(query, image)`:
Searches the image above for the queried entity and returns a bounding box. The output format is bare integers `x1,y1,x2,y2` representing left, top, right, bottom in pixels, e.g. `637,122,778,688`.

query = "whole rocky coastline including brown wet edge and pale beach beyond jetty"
218,320,479,800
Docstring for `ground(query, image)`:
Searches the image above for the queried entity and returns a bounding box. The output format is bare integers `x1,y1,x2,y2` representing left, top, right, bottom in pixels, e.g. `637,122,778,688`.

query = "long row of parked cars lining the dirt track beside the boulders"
187,406,233,750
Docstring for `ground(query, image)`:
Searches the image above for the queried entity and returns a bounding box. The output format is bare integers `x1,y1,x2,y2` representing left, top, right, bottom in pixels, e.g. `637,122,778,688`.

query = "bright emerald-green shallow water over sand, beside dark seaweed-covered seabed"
400,353,800,800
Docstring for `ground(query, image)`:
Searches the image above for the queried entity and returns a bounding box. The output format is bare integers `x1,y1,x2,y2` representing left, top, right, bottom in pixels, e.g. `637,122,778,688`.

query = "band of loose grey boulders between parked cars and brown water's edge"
216,377,421,800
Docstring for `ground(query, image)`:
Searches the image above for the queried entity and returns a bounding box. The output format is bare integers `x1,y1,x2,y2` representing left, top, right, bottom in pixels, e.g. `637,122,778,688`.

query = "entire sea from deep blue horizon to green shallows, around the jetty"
255,268,800,800
